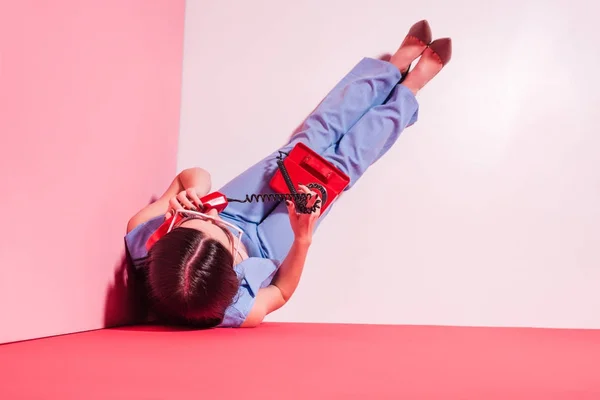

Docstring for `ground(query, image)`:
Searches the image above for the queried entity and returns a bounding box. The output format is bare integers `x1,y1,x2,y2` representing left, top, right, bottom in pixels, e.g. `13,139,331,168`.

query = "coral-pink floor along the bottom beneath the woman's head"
0,323,600,400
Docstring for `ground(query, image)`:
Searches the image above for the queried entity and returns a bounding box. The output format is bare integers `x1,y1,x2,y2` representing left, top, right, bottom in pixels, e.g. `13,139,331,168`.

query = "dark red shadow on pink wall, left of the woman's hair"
104,197,157,328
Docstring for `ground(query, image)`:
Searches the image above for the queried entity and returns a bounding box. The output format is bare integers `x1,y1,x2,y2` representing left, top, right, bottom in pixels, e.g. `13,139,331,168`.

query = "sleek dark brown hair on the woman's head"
147,227,240,328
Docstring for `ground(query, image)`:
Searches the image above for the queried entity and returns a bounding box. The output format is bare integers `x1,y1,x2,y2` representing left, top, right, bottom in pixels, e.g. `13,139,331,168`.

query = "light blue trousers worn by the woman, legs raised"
220,58,418,262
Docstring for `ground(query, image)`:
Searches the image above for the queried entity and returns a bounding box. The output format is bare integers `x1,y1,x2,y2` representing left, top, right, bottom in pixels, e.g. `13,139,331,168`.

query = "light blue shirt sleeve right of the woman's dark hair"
219,257,280,328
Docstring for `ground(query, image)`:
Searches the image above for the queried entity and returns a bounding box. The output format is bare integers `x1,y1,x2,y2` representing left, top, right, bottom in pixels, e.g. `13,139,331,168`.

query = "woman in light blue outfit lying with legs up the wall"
125,21,452,328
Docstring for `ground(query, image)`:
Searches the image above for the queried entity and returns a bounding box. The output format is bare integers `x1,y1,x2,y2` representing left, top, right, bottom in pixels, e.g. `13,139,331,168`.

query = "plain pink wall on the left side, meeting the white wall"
0,0,185,342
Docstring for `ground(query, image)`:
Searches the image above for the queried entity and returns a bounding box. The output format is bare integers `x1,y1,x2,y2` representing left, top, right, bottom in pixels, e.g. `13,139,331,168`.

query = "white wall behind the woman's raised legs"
179,0,600,328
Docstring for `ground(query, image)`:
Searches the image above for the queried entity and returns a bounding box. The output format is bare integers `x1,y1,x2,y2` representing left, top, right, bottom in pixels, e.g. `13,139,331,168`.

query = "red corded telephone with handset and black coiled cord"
146,143,350,249
